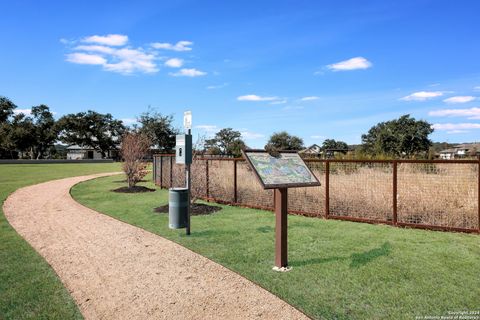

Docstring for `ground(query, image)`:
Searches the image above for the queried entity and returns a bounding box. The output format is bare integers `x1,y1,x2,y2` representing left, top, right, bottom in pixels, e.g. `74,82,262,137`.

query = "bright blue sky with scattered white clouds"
0,0,480,147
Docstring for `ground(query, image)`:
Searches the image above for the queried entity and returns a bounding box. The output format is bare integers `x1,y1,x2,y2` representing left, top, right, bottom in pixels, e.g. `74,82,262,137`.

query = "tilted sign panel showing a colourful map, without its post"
243,150,320,189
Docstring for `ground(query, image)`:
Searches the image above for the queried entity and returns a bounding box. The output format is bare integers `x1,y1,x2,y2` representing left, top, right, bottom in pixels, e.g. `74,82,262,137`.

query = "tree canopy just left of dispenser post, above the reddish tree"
137,110,179,152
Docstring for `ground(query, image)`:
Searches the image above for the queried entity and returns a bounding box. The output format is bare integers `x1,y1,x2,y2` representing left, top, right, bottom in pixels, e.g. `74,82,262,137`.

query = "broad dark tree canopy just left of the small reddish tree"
58,110,125,157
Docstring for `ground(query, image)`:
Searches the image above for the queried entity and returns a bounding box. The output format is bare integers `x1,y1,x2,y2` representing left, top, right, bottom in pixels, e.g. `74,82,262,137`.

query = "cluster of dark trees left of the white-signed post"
0,96,179,159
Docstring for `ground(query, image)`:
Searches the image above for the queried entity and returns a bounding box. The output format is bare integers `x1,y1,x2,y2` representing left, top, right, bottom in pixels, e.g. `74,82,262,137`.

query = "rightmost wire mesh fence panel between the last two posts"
397,163,479,229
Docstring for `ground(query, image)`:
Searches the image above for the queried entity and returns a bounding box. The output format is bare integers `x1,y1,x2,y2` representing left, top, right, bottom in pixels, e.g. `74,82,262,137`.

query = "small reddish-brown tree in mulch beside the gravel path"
121,133,151,188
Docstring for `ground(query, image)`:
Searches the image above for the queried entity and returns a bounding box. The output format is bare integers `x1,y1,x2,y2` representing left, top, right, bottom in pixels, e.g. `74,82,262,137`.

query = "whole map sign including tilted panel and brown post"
242,150,320,271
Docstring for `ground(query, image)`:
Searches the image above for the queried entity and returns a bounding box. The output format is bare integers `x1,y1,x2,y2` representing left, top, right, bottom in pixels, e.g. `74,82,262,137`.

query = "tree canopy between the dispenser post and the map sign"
205,128,246,157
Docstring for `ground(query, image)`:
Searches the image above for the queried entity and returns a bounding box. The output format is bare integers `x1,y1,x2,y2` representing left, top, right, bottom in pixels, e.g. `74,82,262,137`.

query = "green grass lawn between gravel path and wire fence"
72,176,480,319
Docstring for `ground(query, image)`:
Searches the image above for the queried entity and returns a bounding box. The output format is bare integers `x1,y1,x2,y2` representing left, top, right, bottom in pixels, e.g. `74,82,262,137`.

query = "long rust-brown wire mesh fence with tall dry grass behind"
153,155,480,233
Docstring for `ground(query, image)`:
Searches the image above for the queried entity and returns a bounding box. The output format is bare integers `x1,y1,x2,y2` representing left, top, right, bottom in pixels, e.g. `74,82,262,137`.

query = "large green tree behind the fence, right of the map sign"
362,114,433,158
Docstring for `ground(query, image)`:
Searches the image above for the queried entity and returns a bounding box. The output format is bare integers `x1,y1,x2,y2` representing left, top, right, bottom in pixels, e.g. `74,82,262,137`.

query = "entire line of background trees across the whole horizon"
0,96,438,159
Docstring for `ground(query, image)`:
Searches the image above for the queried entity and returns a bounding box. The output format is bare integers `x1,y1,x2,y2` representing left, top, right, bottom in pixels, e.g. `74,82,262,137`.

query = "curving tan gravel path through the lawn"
3,174,307,319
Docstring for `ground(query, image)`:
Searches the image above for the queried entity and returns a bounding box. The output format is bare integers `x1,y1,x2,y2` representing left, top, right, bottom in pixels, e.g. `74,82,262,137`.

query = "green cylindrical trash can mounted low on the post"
168,188,188,229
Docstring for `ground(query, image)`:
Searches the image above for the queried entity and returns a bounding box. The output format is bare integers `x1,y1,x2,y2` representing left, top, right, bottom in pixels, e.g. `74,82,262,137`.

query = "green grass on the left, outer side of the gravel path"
0,163,120,319
